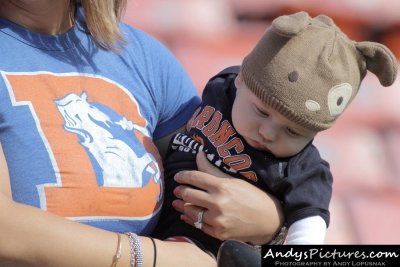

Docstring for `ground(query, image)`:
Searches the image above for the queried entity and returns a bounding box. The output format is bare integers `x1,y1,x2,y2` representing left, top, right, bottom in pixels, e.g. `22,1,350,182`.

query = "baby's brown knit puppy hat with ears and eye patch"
241,12,397,131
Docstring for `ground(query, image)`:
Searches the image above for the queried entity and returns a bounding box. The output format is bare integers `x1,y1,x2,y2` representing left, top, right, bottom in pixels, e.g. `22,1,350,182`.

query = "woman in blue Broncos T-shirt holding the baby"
0,0,280,267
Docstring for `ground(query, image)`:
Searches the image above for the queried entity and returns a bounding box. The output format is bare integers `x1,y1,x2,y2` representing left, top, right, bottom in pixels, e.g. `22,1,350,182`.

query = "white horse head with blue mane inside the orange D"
55,91,160,191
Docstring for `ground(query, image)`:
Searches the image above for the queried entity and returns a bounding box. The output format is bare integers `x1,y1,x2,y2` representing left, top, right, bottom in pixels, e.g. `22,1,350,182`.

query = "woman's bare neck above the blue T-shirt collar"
0,0,74,34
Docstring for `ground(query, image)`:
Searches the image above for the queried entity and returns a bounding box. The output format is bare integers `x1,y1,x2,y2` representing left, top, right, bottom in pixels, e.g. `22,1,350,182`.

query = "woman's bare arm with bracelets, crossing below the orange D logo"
0,146,215,267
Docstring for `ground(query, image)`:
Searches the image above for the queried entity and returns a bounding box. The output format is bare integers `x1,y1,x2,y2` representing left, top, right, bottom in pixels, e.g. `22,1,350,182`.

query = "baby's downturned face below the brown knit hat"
232,75,317,157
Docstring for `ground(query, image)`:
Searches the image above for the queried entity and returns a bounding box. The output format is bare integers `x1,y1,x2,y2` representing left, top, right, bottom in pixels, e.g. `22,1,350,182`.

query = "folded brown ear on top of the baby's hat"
271,11,311,37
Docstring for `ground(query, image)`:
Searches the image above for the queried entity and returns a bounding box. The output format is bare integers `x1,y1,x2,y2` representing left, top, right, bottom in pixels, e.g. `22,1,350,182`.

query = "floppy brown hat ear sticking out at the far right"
355,41,398,86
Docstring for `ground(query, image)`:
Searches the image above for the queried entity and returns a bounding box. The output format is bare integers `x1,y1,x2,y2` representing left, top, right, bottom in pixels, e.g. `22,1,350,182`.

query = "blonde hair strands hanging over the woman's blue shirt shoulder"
77,0,127,52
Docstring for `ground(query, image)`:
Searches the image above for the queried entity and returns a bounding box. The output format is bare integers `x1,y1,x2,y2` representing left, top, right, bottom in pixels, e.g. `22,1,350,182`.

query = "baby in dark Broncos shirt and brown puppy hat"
152,12,397,262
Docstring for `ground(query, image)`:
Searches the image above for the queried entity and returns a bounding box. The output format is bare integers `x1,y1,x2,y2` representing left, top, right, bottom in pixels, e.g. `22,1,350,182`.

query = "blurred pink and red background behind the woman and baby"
124,0,400,244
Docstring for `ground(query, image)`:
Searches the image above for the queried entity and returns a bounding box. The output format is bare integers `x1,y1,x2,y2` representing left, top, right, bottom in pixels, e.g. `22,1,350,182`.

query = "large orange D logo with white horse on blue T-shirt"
3,72,162,218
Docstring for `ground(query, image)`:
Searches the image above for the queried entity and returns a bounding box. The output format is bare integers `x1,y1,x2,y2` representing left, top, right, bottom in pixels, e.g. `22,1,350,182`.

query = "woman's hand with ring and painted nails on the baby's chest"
173,153,283,245
